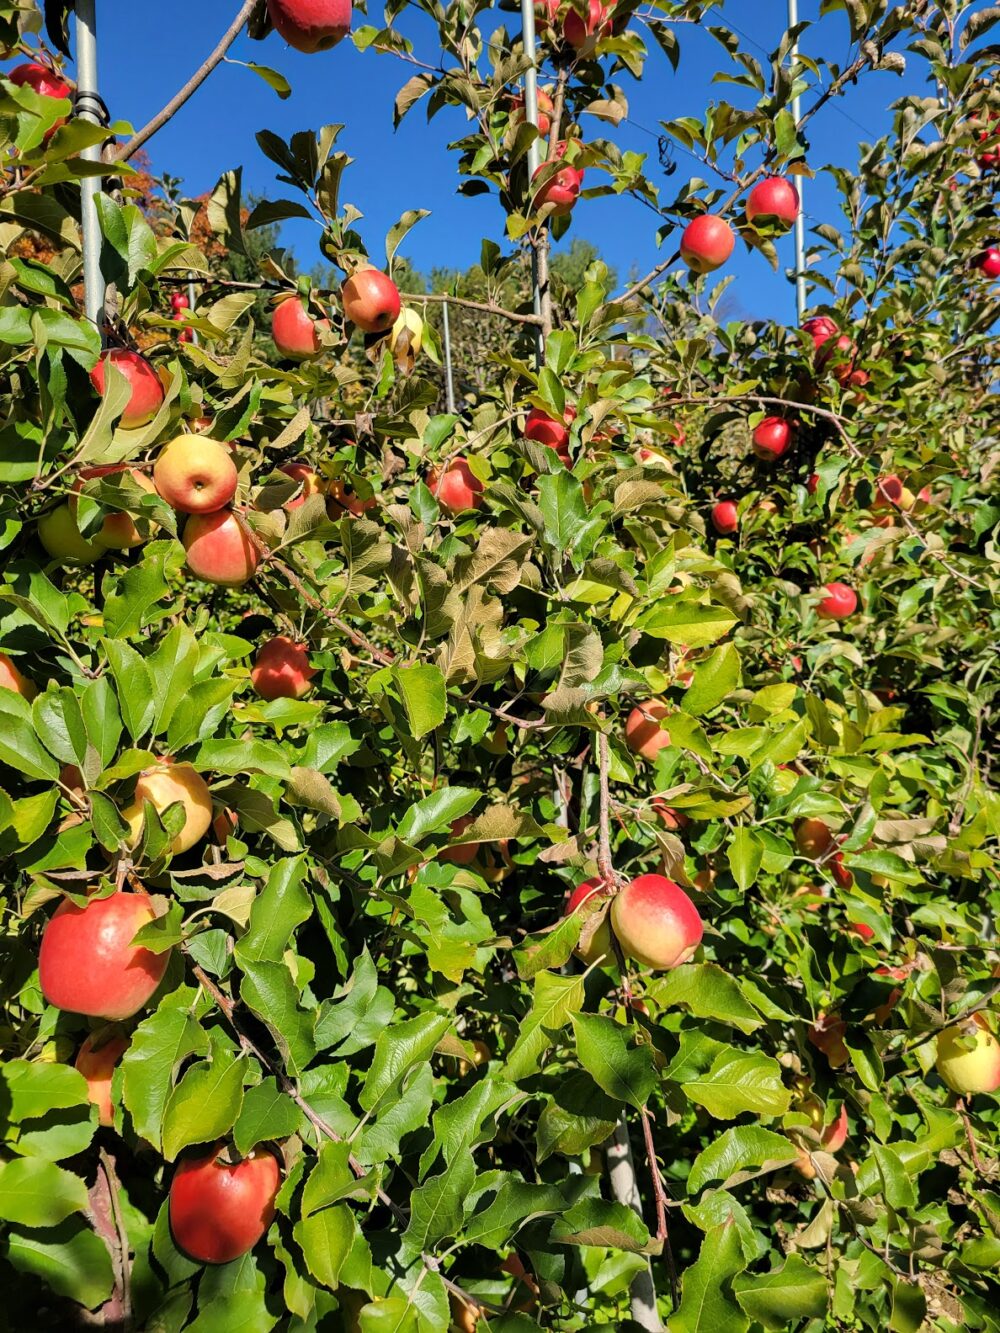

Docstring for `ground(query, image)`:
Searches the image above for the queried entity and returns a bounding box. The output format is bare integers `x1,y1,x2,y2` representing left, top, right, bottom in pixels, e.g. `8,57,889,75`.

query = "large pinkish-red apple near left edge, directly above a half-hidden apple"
39,892,171,1020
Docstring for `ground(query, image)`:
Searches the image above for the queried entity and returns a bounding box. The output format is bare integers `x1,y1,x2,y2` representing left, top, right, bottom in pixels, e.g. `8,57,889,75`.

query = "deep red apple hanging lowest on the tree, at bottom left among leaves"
169,1142,281,1264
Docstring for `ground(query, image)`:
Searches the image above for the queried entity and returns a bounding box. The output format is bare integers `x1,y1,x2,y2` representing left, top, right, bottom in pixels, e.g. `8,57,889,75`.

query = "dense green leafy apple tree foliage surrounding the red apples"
0,0,1000,1333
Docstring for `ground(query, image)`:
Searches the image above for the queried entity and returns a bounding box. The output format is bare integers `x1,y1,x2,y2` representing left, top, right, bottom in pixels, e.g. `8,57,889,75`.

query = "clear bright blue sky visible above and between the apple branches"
68,0,949,319
